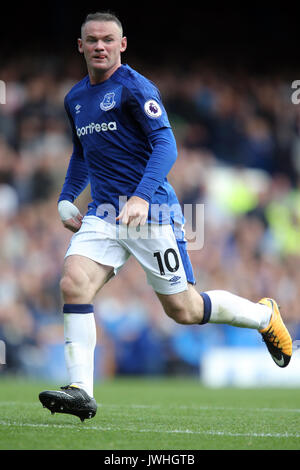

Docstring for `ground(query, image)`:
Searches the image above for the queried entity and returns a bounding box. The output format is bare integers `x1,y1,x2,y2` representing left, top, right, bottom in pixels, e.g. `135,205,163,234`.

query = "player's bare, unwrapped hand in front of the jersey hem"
116,196,149,227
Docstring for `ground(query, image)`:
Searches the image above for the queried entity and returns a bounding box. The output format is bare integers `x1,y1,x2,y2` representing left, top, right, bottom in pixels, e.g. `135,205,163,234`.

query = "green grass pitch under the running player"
0,377,300,450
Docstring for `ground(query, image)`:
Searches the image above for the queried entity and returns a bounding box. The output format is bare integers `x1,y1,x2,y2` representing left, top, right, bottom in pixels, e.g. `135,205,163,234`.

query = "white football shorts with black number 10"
65,215,195,294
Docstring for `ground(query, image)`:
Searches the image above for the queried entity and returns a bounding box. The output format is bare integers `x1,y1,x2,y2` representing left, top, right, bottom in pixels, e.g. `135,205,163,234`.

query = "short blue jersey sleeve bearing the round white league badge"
125,83,171,135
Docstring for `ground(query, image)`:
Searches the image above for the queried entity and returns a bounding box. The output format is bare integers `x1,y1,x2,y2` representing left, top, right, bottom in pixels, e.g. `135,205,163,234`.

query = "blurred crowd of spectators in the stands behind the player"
0,52,300,380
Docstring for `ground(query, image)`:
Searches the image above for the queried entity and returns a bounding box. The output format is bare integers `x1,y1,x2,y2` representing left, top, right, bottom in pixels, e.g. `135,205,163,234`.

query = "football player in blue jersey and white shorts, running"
39,12,292,420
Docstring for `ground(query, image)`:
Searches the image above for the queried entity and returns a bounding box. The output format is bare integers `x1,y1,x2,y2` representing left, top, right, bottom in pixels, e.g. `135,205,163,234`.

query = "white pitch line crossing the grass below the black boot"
0,421,300,439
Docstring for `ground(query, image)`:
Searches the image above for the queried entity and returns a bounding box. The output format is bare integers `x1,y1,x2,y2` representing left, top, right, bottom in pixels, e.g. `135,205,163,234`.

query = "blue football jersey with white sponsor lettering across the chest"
63,65,182,223
